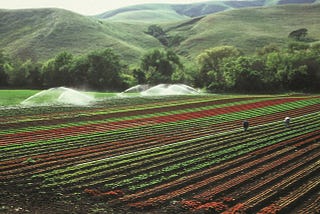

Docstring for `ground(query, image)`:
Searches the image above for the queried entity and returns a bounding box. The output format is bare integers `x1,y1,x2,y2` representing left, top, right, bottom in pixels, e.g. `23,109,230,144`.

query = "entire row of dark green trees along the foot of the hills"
0,42,320,93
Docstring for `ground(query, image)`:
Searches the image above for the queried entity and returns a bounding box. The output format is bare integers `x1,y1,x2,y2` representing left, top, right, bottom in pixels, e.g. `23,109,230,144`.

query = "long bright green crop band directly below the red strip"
0,99,319,160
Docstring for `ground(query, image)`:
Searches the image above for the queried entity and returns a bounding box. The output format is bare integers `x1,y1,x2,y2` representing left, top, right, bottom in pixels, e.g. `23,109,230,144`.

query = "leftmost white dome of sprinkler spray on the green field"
21,87,95,106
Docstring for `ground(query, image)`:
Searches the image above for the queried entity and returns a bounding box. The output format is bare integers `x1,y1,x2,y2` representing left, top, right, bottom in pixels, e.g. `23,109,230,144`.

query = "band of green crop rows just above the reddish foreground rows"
30,112,319,190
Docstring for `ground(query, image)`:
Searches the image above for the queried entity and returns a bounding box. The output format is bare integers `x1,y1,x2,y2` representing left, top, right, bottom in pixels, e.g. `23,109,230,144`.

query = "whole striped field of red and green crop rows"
0,95,320,214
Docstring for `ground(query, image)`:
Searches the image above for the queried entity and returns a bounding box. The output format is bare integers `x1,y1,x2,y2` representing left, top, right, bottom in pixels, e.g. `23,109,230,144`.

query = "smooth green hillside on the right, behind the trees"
166,4,320,58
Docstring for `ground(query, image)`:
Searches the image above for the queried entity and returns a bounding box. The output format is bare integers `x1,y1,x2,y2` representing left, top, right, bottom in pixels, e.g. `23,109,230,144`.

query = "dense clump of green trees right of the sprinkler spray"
196,42,320,92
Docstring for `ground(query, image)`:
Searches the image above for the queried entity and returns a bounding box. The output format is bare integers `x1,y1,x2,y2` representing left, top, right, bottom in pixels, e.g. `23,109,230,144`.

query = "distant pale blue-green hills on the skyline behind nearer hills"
97,0,319,23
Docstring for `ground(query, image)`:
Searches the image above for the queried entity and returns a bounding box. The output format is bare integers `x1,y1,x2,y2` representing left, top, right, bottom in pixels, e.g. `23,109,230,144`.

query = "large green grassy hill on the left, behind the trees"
0,9,159,62
